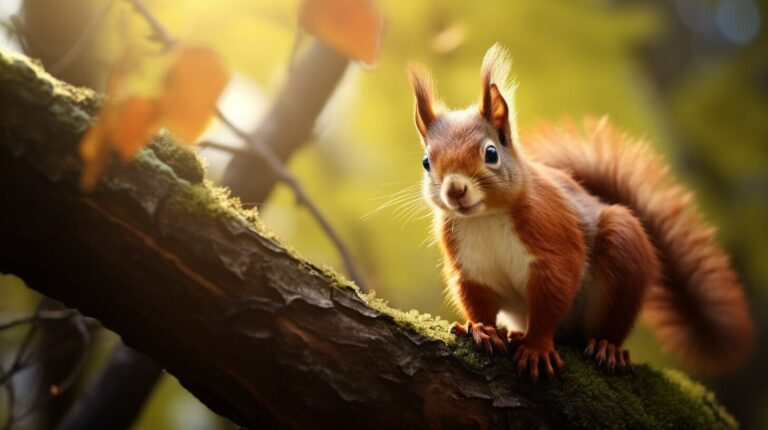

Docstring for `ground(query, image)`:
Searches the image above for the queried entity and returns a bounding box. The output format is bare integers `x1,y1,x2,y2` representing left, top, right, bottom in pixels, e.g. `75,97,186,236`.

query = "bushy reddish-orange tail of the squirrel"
523,118,754,373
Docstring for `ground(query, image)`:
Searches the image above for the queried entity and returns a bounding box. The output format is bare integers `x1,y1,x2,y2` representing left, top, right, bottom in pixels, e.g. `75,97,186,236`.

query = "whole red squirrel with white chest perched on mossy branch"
410,45,753,381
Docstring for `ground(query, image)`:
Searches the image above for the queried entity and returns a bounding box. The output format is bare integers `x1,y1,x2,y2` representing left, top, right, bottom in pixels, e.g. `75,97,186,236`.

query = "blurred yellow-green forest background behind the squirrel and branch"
0,0,768,429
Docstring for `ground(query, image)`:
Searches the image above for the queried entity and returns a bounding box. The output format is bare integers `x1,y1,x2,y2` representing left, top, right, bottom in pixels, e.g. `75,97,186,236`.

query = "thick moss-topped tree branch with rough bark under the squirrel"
0,54,734,428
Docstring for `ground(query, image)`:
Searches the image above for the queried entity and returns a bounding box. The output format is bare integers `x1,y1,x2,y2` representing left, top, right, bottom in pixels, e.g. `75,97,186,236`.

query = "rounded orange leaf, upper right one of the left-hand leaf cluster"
158,48,229,142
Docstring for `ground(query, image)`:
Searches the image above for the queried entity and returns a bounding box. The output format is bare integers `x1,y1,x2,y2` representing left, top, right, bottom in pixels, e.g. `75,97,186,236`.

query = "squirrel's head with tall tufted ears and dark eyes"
410,44,524,217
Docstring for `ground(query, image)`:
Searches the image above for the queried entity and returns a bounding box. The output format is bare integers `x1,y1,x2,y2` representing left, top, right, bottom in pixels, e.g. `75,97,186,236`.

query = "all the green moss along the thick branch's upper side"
0,49,736,429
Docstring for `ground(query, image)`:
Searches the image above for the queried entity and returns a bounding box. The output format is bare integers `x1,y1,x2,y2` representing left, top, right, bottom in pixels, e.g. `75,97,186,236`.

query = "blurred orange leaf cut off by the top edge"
299,0,382,65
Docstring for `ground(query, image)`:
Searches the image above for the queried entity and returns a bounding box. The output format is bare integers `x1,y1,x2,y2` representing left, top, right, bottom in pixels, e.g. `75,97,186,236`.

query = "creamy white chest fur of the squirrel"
453,213,534,302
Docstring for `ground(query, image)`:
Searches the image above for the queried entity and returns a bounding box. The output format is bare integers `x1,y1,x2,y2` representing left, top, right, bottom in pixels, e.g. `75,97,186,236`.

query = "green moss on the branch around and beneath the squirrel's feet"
362,293,738,429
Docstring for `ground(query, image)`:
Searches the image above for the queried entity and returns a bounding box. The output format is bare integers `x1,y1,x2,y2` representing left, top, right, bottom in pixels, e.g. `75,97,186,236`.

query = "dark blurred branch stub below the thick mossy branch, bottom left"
56,343,162,430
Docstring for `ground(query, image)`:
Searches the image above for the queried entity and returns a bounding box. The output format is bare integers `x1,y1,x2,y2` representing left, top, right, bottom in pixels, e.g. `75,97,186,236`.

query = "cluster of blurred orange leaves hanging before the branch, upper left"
80,47,229,191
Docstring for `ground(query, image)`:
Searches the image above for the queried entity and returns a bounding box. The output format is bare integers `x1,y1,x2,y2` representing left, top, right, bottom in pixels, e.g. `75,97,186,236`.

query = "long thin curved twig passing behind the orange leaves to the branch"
128,0,364,289
